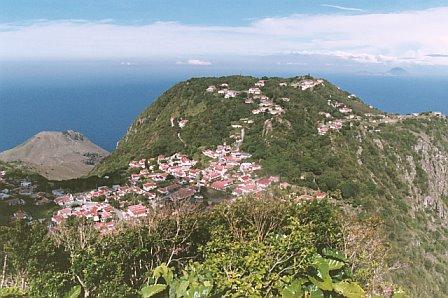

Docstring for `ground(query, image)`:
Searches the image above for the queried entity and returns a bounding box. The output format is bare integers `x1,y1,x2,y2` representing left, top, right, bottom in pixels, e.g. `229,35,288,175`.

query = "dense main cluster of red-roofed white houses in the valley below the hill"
52,136,279,233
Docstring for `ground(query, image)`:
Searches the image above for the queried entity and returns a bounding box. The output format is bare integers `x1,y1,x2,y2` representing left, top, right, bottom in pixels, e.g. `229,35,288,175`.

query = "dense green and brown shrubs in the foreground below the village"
0,198,380,297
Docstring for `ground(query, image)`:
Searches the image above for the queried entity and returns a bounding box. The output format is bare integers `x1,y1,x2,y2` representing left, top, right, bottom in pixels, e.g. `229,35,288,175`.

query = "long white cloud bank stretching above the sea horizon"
0,7,448,65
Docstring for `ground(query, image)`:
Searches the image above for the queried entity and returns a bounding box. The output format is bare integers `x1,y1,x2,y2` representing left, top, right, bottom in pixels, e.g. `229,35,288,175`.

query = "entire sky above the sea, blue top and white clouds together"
0,0,448,74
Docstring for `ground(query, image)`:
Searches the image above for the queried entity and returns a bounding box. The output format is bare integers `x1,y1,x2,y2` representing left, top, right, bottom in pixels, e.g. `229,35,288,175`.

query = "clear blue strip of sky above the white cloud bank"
0,0,448,26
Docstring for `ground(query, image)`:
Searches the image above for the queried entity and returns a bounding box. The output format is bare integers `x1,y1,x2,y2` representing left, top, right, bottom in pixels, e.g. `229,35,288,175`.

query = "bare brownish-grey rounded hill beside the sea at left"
0,130,109,180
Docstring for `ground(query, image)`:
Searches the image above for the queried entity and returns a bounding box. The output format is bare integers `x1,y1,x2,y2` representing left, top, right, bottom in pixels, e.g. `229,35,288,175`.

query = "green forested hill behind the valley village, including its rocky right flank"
92,76,448,297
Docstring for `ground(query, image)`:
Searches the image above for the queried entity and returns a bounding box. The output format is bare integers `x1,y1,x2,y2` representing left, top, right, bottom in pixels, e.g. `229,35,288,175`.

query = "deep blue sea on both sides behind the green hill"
0,63,448,151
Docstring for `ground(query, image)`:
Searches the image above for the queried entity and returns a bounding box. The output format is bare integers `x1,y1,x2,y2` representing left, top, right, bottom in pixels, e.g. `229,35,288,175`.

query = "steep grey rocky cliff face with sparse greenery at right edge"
358,116,448,297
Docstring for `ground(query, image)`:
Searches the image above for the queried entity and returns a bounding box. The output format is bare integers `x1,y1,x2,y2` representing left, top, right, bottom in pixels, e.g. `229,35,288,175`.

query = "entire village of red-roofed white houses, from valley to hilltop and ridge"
0,79,444,233
